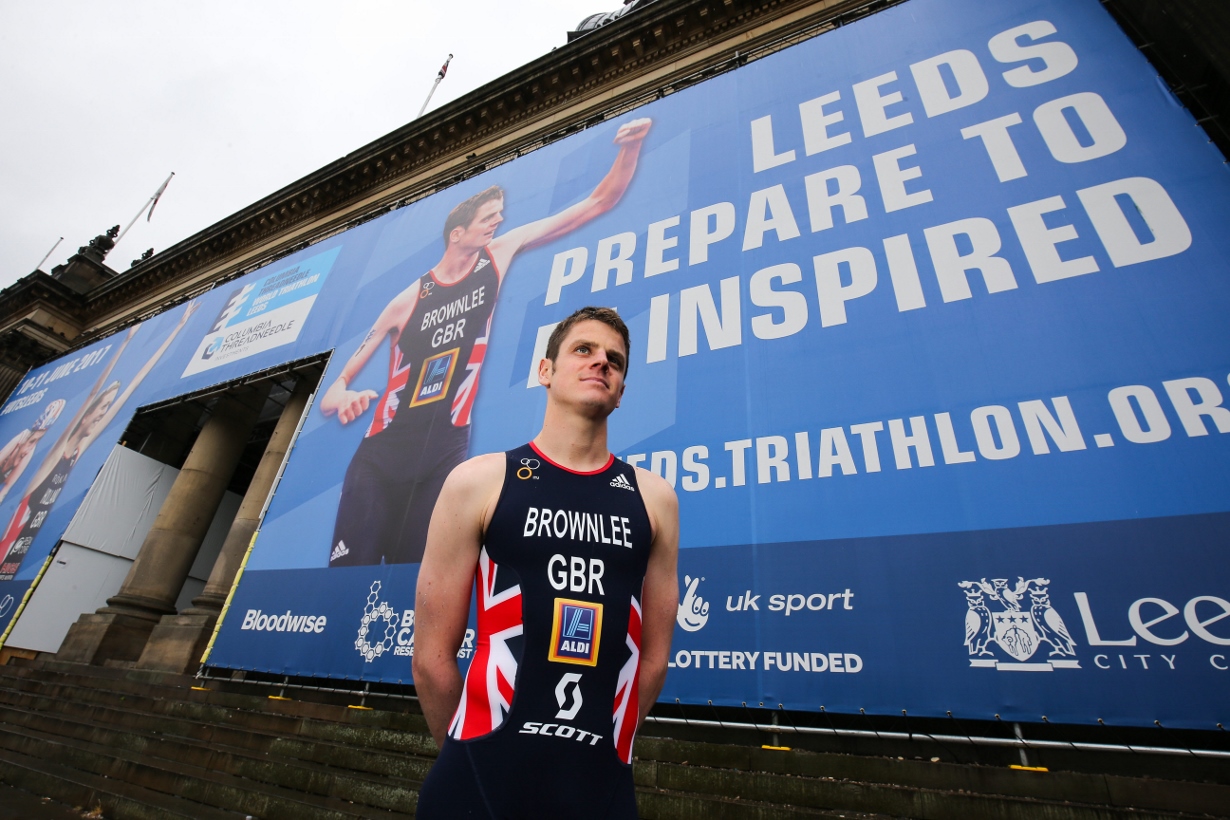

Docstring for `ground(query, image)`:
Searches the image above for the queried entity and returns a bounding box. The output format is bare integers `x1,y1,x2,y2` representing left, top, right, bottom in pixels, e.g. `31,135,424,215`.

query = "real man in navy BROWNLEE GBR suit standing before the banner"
413,307,679,820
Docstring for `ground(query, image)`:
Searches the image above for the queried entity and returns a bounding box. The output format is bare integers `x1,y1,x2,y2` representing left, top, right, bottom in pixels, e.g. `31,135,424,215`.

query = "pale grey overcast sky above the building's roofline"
0,0,620,288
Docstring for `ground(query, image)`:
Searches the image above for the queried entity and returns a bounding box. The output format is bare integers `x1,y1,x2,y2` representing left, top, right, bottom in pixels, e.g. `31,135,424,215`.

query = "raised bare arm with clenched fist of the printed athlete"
490,119,652,270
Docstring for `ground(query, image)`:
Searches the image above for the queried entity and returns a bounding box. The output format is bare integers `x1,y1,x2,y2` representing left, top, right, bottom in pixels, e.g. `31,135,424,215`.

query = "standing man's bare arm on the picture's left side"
412,452,504,747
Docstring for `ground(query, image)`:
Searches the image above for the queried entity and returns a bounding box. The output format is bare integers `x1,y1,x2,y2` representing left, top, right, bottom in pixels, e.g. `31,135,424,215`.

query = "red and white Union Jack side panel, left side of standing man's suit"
449,547,521,740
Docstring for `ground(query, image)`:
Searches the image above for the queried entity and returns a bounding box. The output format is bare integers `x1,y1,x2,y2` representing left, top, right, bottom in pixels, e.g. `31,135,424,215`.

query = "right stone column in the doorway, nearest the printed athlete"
137,379,315,672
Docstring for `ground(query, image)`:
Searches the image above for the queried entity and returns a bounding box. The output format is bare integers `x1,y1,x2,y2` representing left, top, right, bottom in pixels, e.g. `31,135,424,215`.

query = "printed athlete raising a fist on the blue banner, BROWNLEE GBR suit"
321,119,649,567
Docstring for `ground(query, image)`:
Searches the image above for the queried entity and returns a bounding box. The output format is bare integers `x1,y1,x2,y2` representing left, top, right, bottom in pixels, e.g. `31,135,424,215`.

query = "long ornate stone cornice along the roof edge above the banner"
76,0,891,337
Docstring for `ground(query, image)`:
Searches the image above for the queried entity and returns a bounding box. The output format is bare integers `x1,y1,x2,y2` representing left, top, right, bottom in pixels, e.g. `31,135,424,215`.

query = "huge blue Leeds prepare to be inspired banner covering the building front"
0,0,1230,728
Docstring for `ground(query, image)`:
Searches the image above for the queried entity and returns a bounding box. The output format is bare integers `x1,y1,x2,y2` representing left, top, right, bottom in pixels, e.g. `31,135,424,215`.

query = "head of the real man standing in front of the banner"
539,320,627,416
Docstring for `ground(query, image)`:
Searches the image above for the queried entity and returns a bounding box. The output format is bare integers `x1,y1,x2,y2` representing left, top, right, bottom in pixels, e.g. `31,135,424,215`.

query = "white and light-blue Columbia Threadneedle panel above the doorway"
180,247,342,379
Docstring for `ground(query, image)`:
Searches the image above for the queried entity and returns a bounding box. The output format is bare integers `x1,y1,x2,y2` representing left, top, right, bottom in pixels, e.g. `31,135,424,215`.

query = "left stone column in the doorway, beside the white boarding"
57,385,268,665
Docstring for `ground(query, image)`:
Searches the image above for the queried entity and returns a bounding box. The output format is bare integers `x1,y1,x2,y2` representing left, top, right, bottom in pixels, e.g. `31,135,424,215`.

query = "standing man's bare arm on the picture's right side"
636,467,679,725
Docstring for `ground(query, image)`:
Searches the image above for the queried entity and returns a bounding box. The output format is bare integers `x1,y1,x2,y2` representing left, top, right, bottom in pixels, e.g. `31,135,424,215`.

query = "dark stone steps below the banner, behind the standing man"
0,660,1230,820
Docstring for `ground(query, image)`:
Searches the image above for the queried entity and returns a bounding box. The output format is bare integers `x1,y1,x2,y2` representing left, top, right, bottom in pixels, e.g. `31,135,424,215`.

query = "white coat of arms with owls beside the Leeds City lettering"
957,577,1080,672
